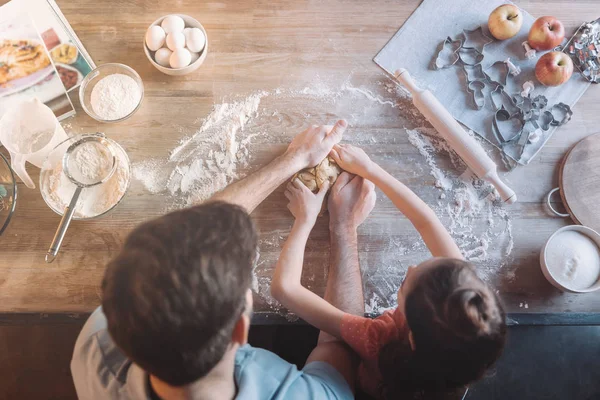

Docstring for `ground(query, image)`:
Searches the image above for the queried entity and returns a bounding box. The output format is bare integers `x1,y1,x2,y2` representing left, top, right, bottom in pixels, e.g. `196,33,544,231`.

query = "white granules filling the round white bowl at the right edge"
546,231,600,290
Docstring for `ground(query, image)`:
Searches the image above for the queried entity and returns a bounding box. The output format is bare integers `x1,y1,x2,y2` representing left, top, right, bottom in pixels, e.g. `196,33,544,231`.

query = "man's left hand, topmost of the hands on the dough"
285,119,348,170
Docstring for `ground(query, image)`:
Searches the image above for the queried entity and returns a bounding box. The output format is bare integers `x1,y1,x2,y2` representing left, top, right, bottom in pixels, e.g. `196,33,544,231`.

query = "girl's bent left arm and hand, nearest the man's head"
271,179,345,338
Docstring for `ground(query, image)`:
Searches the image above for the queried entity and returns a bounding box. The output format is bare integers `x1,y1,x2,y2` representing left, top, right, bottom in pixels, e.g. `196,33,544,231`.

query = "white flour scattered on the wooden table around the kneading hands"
133,75,511,313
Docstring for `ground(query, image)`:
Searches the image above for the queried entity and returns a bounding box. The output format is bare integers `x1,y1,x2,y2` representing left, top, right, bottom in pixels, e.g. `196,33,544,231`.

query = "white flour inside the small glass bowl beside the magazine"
90,74,142,121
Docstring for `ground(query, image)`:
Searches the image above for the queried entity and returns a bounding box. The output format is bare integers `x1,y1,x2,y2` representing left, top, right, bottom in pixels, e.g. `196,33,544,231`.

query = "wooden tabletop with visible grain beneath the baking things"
0,0,600,313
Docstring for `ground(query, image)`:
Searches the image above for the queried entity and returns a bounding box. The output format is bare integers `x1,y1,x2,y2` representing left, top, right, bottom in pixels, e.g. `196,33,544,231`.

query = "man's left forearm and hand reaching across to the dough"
211,120,348,213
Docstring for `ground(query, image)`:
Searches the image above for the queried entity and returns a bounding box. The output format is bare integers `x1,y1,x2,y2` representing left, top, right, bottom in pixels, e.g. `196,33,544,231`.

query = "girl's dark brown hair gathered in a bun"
378,259,506,400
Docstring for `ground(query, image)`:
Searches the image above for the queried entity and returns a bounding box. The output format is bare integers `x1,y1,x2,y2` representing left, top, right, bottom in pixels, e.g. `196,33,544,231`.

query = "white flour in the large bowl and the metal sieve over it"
42,145,130,218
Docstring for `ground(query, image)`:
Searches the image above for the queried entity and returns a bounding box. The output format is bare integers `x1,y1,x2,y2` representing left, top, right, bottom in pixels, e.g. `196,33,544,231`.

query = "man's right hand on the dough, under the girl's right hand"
328,172,377,231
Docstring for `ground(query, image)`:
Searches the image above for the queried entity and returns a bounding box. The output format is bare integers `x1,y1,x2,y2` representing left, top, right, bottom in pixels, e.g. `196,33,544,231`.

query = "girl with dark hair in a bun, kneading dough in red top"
271,145,506,399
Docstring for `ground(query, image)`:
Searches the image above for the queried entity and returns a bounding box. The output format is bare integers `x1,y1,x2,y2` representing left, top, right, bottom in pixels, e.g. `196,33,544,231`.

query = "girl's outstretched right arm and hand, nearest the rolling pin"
330,145,464,259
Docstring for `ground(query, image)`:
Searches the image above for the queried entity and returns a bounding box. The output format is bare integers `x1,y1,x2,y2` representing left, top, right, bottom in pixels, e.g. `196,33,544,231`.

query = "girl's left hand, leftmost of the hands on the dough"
284,178,329,225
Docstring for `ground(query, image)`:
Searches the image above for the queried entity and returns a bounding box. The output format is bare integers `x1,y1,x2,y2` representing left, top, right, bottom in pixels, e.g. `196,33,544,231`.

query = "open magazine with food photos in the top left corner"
0,0,96,120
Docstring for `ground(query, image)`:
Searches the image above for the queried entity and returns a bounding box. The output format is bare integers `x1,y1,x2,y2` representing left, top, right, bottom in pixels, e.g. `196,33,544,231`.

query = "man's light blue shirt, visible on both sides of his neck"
71,307,353,400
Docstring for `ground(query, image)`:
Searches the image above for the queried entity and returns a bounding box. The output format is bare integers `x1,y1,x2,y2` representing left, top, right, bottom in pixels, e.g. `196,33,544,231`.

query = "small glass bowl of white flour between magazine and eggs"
79,63,144,122
